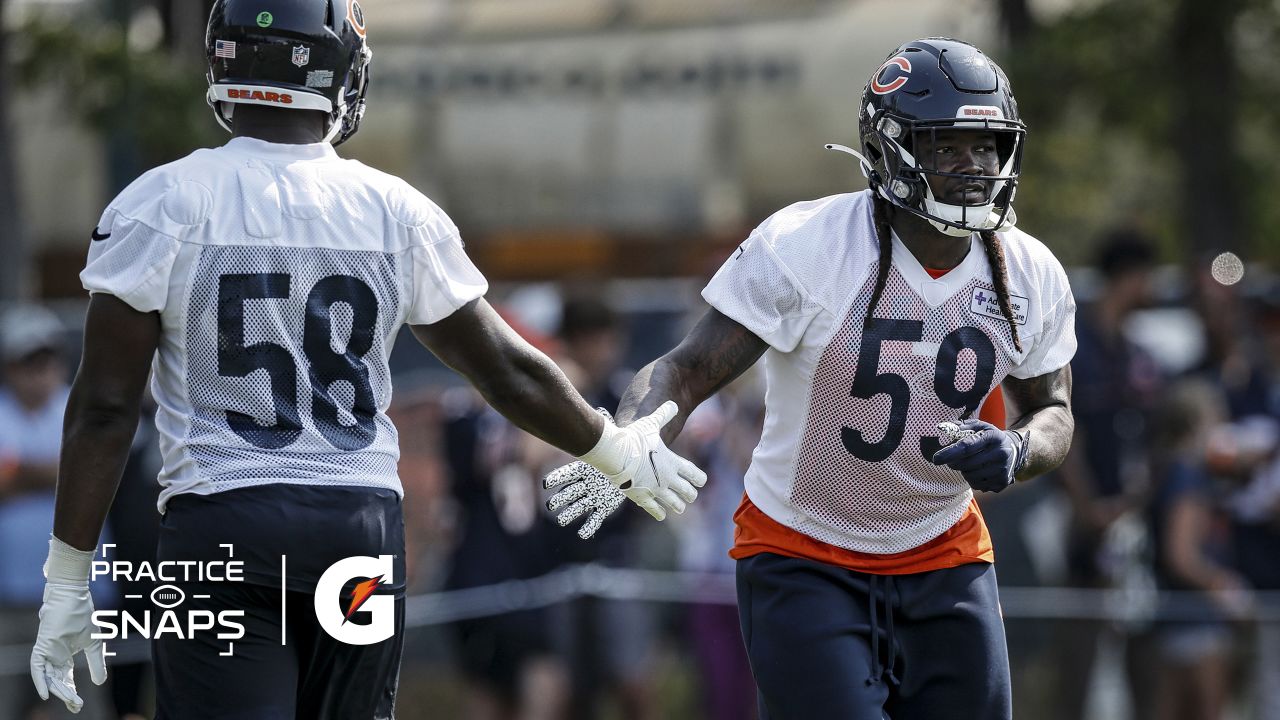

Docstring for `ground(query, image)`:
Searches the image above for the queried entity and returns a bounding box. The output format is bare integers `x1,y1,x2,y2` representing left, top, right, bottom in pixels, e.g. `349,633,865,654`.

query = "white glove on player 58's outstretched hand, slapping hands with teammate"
563,400,707,520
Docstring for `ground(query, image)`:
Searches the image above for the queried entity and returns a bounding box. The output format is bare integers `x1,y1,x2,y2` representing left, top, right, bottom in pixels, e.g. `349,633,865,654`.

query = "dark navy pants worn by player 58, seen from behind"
151,484,404,720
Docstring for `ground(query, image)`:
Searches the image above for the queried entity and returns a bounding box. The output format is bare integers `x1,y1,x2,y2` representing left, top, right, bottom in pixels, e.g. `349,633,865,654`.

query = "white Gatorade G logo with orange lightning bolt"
315,555,396,644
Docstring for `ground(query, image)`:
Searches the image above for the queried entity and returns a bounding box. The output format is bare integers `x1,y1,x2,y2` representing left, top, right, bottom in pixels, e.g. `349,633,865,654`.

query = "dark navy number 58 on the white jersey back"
218,273,378,450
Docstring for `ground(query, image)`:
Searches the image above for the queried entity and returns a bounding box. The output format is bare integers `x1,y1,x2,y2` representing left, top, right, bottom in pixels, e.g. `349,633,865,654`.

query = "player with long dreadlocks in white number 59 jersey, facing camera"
552,37,1075,720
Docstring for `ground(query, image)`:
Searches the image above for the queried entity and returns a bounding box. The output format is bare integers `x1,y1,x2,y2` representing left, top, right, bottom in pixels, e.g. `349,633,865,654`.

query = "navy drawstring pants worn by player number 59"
737,553,1012,720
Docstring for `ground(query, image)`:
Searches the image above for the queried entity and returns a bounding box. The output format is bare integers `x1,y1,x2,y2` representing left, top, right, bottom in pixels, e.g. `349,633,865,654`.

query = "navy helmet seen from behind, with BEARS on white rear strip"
205,0,372,145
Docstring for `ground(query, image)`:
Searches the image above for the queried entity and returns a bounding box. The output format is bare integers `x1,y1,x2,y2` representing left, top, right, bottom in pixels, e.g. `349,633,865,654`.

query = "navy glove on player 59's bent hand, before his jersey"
933,418,1027,492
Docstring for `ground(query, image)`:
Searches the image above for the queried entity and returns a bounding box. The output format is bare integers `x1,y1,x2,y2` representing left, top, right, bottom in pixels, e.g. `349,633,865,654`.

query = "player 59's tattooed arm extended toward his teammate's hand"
617,309,769,443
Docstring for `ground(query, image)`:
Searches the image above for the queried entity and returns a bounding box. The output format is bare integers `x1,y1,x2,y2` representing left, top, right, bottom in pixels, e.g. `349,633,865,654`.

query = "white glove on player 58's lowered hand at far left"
31,537,106,712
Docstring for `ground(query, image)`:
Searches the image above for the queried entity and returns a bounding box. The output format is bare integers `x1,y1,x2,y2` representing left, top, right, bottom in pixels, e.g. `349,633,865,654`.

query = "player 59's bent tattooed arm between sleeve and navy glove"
1004,365,1075,480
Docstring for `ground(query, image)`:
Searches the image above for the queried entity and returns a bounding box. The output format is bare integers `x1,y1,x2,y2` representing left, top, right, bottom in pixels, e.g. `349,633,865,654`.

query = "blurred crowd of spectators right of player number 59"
984,231,1280,720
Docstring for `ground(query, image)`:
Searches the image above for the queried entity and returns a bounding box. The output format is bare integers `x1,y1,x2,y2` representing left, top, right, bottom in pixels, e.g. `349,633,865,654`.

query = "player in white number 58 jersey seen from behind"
31,0,705,720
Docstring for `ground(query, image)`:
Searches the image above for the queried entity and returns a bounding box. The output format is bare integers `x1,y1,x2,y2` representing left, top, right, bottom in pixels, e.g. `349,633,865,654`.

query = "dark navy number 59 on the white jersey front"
840,318,996,462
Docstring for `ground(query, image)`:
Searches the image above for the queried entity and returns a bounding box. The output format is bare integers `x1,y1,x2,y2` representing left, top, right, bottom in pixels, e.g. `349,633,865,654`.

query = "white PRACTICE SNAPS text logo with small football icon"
91,543,244,656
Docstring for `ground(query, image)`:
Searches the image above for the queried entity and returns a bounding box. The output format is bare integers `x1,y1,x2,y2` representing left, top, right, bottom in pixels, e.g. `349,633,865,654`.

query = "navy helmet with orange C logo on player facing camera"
828,37,1027,237
